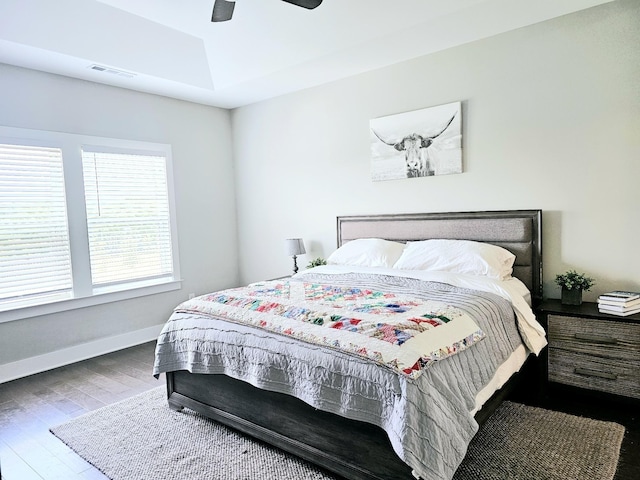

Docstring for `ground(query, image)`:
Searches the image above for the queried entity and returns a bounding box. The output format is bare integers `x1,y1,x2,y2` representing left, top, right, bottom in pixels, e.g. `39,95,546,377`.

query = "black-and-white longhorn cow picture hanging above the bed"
369,102,462,181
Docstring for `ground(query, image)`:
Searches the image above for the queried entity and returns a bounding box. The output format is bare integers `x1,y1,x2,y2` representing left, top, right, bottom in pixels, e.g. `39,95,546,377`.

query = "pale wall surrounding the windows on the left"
0,64,238,372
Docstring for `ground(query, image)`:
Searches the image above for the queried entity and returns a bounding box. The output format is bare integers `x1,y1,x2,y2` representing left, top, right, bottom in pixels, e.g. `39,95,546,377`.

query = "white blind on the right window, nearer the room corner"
82,147,174,286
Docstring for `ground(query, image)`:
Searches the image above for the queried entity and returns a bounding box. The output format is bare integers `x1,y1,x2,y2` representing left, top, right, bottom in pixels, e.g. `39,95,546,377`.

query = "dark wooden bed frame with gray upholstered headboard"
166,210,542,480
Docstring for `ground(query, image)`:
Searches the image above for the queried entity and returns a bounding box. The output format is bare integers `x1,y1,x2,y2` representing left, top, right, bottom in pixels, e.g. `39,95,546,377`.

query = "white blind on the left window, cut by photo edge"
0,144,72,304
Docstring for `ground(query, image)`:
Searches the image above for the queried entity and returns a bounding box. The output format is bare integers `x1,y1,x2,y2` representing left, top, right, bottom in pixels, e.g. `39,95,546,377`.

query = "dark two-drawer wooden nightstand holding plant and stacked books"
538,300,640,399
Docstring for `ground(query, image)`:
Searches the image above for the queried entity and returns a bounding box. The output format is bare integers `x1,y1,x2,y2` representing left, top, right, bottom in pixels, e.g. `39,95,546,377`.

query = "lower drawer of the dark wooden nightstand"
549,348,640,399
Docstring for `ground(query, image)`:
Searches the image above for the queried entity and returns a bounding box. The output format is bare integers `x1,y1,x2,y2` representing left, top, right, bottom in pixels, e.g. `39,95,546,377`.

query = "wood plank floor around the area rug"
0,342,640,480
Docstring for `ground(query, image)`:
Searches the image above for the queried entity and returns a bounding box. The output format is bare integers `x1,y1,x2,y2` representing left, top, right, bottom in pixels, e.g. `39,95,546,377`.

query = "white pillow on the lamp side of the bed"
327,238,404,268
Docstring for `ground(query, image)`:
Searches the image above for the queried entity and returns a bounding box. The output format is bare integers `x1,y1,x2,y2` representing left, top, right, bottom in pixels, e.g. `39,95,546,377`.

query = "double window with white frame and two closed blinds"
0,127,180,321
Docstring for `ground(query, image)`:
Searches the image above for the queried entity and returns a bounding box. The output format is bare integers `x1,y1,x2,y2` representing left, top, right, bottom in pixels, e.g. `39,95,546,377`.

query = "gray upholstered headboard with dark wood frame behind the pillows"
337,210,542,301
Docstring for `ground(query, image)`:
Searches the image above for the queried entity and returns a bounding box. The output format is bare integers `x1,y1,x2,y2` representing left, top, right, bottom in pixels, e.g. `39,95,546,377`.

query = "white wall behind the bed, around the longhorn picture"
232,0,640,300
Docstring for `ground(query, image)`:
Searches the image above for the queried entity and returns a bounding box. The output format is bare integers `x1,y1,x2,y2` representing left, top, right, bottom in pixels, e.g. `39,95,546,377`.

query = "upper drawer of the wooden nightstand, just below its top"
548,315,640,362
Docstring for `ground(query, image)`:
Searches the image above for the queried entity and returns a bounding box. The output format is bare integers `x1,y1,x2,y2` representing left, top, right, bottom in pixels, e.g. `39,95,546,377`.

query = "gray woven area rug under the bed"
51,387,624,480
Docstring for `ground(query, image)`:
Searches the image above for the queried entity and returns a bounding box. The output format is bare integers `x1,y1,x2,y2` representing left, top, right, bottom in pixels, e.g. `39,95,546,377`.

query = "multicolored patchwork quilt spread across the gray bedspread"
176,280,485,379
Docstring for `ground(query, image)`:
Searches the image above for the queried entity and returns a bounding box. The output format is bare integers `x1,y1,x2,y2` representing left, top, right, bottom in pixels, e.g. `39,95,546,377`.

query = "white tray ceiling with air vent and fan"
0,0,612,108
